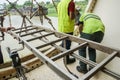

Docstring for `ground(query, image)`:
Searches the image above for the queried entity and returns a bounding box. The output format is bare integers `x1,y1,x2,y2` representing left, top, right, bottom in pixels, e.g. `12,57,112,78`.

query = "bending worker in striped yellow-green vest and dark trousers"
76,13,105,73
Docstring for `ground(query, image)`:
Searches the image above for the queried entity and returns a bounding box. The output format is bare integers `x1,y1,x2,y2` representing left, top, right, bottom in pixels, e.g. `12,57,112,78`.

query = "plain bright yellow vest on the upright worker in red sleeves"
57,0,75,33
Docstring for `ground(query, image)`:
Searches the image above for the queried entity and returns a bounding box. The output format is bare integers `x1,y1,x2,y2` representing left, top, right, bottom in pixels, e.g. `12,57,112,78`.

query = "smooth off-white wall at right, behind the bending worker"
93,0,120,80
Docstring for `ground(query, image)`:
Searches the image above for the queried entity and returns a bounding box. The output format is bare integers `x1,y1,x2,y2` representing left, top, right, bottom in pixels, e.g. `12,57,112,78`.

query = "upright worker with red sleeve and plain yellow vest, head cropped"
57,0,75,64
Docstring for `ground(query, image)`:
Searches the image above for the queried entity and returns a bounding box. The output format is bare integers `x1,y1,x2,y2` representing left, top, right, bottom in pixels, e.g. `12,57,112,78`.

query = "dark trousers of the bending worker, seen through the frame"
79,31,104,70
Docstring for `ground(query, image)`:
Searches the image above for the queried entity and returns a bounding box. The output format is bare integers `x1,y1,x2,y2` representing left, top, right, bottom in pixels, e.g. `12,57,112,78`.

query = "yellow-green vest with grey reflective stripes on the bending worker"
80,13,105,34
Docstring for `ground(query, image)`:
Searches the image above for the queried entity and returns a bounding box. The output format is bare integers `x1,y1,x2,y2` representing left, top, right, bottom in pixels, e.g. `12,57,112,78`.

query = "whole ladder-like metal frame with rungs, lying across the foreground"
6,26,120,80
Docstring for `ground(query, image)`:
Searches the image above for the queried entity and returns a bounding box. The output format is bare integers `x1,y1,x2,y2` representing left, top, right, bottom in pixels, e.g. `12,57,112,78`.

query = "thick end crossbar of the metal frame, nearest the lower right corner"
82,51,118,80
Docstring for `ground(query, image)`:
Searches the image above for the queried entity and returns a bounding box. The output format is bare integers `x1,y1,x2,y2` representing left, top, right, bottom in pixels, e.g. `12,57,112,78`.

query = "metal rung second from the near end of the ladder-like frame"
52,42,88,60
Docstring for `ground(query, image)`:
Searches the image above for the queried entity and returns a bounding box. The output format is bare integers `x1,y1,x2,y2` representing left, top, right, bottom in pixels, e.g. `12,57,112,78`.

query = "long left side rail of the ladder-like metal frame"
10,32,81,80
